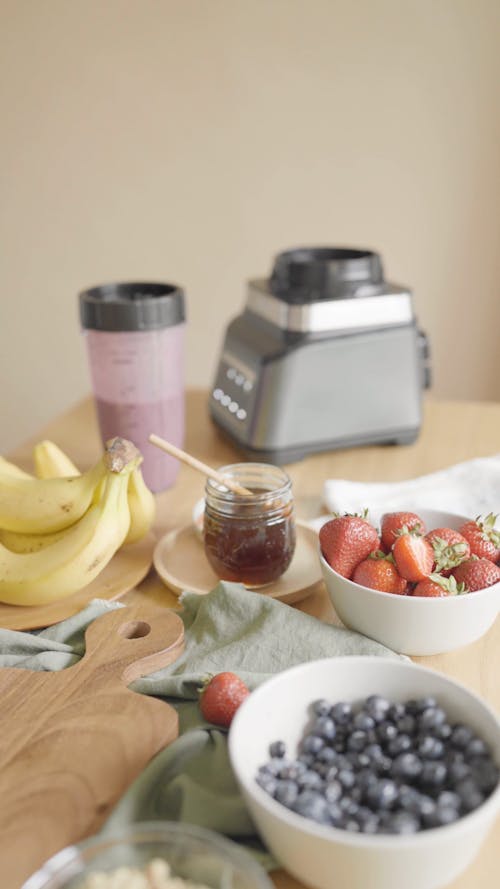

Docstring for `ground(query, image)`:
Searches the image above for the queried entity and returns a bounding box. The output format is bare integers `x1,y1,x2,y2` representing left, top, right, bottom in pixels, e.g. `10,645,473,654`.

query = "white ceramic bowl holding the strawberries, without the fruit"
318,509,500,655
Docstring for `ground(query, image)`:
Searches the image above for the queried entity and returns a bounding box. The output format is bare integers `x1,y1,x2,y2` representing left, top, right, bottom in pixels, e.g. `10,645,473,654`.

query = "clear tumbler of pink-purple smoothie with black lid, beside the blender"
83,284,185,492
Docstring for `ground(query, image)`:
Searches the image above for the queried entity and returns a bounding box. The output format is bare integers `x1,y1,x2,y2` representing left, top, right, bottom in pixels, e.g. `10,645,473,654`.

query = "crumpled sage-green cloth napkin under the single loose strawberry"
0,582,400,868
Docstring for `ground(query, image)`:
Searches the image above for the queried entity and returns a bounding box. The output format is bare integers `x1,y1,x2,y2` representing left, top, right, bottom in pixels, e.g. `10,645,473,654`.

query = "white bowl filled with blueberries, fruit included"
229,657,500,889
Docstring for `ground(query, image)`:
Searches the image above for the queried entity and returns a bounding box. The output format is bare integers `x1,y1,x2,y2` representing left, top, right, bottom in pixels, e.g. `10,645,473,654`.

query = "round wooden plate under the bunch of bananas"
0,531,156,630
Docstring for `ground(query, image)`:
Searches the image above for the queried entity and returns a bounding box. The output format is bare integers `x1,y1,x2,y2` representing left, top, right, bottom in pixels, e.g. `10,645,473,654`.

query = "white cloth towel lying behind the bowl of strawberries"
315,455,500,524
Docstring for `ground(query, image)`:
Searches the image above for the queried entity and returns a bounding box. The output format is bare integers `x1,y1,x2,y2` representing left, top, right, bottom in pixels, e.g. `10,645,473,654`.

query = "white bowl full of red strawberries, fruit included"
319,509,500,655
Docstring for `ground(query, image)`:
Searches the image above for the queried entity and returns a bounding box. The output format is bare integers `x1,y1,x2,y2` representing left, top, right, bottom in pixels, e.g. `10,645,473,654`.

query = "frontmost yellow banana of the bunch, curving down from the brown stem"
0,470,130,605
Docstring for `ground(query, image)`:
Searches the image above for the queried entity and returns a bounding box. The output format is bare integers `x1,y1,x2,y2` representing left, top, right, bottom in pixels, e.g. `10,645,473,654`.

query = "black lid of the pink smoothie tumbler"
79,281,186,331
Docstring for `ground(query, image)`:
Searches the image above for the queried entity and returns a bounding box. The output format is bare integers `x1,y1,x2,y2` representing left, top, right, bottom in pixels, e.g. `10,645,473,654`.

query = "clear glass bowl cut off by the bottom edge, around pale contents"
22,821,273,889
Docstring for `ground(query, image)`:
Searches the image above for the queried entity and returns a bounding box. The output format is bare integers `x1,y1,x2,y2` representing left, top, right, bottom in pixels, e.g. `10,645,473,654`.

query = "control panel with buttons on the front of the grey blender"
210,352,256,426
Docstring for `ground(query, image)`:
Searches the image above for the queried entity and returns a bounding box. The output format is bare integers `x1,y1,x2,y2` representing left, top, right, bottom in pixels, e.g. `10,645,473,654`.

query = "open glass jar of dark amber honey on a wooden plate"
203,463,295,589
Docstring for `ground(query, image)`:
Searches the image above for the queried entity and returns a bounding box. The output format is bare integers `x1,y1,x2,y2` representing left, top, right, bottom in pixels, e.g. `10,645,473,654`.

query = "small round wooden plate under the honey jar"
153,522,322,605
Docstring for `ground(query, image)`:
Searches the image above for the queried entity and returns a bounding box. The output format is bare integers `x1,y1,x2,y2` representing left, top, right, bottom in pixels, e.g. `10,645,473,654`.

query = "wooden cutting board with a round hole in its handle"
0,604,184,889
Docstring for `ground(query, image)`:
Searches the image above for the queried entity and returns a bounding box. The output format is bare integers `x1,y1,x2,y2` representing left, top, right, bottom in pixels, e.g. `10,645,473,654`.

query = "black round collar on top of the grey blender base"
270,247,384,303
